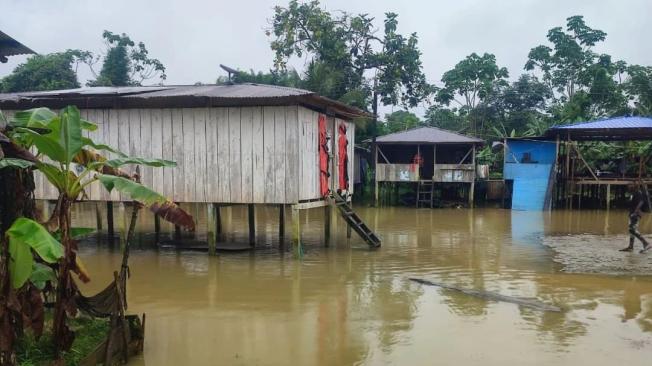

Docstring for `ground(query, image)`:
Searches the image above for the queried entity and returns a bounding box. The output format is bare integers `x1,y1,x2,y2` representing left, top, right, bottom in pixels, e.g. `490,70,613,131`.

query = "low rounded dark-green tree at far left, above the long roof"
0,50,83,93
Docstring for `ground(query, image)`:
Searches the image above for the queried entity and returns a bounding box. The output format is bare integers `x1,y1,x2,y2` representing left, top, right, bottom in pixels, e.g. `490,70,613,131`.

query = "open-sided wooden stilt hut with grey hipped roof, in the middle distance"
375,127,484,207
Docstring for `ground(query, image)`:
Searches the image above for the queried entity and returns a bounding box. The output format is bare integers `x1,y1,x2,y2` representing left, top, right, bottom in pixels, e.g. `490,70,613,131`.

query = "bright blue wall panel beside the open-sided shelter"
503,140,557,211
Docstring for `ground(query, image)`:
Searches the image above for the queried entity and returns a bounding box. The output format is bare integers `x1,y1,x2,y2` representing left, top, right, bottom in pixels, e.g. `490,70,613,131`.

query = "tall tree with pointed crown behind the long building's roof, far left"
88,30,166,86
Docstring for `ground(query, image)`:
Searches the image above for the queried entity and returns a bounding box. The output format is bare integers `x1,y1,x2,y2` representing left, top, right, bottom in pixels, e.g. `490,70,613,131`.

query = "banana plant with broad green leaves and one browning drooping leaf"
8,106,195,356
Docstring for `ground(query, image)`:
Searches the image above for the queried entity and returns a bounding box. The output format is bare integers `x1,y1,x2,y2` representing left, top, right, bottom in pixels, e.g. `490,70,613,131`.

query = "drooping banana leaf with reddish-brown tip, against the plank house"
97,174,195,230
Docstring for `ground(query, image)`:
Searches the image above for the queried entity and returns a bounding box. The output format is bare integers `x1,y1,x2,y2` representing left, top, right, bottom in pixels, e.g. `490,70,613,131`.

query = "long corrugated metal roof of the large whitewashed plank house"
0,83,369,118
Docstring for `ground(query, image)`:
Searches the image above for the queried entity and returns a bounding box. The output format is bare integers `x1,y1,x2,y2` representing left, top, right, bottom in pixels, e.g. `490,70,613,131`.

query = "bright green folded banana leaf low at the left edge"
6,217,64,288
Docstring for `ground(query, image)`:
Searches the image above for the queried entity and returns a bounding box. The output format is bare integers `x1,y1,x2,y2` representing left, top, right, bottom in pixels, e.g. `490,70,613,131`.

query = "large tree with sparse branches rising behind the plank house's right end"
267,0,430,138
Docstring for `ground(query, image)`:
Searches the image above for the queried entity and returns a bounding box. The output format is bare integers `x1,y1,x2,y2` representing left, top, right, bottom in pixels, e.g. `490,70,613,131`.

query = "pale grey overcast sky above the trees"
0,0,652,113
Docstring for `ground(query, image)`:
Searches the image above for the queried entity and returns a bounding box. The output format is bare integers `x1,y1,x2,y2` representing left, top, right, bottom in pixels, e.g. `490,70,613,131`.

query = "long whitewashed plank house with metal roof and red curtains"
0,84,365,247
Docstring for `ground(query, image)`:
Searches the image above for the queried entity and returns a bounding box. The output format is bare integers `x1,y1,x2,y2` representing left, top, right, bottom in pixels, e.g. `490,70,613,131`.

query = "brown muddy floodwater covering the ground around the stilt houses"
69,205,652,366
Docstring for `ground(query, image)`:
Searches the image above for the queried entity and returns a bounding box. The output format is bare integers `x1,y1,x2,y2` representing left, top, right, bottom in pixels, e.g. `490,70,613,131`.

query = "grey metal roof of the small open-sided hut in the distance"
376,127,484,144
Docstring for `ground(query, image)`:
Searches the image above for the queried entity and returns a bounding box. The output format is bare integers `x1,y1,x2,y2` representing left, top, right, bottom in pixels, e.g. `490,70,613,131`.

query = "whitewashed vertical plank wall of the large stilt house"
13,106,332,204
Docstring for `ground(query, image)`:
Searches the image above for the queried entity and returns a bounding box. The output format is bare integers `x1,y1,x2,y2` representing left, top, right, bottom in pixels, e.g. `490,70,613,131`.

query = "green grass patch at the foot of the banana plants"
16,317,109,366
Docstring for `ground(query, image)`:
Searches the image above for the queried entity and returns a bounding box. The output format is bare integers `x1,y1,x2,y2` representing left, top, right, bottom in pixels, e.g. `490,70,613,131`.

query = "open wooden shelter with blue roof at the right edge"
544,117,652,208
